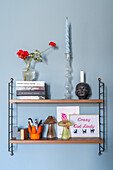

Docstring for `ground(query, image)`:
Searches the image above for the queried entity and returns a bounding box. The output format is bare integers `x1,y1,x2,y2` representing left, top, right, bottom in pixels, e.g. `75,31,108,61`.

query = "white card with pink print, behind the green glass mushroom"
57,106,79,138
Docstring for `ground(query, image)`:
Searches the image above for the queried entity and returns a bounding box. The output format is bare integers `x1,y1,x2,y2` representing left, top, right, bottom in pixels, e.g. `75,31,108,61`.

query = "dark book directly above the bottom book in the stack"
16,90,45,96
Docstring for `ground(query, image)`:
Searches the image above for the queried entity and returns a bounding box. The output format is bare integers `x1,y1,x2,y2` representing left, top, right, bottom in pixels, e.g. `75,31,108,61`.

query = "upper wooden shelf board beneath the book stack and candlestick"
9,99,103,104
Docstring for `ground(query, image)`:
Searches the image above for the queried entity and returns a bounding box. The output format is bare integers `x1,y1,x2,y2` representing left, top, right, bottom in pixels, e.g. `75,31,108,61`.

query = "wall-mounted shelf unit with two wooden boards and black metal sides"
8,78,105,155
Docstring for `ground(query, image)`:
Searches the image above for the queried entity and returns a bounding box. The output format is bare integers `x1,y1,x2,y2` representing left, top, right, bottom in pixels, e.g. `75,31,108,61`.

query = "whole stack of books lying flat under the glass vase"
16,81,45,99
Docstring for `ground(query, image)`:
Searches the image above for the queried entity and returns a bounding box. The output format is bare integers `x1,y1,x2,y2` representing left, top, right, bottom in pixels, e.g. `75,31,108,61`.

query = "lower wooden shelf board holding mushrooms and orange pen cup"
10,138,104,144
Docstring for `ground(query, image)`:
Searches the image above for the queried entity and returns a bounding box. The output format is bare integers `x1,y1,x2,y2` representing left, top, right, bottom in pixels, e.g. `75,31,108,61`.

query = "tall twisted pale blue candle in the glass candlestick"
65,17,70,54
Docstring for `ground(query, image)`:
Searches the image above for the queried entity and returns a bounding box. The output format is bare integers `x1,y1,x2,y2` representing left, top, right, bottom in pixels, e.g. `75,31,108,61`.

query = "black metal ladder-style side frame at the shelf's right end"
98,78,105,155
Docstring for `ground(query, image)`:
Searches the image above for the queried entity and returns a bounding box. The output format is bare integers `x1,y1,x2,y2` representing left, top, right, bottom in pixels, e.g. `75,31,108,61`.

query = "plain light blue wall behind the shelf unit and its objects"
0,0,113,170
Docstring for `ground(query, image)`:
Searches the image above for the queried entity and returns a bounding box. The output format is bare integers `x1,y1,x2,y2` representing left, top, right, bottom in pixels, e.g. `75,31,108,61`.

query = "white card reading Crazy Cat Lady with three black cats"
69,115,99,137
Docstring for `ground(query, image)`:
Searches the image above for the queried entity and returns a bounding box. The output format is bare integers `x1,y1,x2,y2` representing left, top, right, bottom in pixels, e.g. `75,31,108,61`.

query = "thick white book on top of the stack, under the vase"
16,81,45,87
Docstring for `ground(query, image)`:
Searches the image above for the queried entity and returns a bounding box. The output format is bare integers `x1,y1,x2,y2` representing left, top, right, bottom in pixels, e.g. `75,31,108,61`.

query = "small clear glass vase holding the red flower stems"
22,68,35,81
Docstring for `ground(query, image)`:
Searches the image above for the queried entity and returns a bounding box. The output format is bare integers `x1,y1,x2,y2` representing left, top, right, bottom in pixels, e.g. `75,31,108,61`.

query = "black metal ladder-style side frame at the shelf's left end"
8,78,14,156
